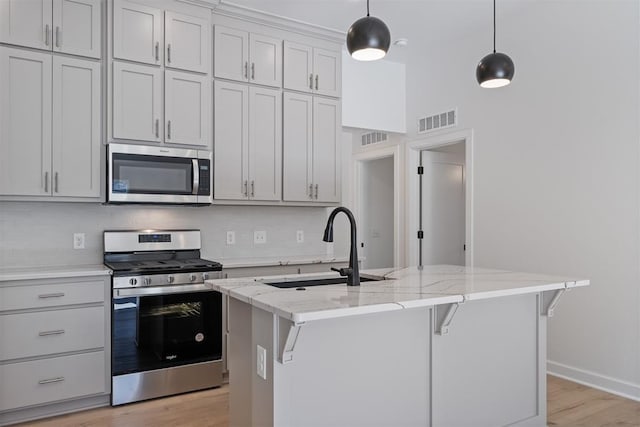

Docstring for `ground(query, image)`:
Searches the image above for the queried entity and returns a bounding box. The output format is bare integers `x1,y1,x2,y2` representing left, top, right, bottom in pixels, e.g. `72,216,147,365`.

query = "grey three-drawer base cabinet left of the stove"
0,275,111,425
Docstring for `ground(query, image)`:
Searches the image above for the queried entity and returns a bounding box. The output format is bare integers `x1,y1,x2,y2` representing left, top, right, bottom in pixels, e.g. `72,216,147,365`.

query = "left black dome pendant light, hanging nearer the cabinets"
347,0,391,61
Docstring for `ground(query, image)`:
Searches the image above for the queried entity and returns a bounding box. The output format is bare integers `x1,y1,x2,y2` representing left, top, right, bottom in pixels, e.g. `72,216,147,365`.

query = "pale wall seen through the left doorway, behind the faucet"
358,157,394,268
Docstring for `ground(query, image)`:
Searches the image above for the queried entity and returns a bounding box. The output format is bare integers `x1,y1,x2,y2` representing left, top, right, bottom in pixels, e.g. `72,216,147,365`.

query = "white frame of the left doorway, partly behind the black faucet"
351,145,405,268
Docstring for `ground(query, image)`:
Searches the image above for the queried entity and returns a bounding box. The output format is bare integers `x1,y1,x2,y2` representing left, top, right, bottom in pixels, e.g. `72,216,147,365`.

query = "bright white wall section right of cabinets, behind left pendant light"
342,50,407,133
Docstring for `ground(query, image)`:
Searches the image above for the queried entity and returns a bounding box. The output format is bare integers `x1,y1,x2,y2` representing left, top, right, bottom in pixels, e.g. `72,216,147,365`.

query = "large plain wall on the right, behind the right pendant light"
407,0,640,399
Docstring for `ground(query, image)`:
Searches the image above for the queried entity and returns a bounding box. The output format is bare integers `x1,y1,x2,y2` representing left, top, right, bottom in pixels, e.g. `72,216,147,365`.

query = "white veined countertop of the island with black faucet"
208,265,589,323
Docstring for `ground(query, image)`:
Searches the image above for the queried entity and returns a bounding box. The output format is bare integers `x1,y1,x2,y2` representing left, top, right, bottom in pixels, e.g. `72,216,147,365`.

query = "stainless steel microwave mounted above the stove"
107,144,213,205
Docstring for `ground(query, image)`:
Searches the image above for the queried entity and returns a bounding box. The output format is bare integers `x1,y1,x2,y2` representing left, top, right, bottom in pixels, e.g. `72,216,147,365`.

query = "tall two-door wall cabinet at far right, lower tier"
282,92,341,202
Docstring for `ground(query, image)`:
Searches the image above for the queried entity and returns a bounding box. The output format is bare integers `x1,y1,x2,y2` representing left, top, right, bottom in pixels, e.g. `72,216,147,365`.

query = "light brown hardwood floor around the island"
20,376,640,427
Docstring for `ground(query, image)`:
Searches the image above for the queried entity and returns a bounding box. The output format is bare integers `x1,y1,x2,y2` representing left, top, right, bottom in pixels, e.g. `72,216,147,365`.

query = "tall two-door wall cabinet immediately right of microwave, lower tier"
214,81,282,201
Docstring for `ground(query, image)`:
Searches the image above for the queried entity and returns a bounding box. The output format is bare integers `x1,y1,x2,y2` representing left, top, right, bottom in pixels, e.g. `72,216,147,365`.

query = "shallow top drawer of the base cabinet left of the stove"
0,280,105,311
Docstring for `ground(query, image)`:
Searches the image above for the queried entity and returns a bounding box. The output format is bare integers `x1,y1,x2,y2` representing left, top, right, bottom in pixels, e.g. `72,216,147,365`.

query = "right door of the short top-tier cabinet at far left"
53,0,101,58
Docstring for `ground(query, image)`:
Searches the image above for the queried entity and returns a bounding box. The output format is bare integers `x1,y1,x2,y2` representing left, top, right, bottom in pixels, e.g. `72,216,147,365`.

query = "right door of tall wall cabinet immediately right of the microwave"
249,87,282,200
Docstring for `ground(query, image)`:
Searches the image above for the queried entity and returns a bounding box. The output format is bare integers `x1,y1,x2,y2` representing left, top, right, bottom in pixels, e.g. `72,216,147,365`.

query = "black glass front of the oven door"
112,290,222,377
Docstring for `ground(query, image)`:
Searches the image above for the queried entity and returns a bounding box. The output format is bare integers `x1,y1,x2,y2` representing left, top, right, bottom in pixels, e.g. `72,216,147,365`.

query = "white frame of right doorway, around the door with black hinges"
405,129,474,267
